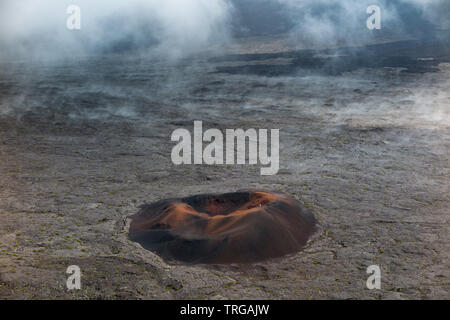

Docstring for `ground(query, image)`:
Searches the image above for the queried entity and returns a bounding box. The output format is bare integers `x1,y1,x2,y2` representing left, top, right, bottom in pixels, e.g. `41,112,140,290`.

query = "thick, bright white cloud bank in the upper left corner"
0,0,230,56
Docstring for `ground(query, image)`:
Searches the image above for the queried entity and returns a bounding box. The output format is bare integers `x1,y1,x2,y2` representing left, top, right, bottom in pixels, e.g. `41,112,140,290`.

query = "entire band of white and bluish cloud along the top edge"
0,0,450,57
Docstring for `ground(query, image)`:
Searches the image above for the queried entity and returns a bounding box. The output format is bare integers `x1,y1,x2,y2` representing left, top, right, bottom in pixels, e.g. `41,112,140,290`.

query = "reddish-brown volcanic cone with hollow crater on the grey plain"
129,190,316,264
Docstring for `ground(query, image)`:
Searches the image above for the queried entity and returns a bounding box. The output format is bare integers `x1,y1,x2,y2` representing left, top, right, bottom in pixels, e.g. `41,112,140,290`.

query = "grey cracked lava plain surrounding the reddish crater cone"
0,37,450,299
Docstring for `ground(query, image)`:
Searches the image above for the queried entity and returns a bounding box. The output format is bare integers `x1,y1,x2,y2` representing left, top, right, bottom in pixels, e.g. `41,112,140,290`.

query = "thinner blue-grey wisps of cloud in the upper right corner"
235,0,450,48
